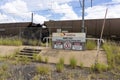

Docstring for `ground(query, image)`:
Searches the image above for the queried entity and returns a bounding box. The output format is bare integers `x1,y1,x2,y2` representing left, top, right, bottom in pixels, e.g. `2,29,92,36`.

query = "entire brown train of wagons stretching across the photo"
0,18,120,40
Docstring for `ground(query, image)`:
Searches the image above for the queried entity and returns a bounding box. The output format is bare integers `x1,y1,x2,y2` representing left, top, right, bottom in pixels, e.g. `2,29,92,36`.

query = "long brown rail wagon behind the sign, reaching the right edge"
45,18,120,39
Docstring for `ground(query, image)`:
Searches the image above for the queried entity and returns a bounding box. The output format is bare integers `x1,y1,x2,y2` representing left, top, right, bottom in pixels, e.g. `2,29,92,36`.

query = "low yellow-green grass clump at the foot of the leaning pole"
91,63,108,73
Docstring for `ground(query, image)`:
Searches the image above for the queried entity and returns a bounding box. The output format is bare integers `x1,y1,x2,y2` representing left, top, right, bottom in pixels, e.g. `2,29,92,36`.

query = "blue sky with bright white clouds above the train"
0,0,120,24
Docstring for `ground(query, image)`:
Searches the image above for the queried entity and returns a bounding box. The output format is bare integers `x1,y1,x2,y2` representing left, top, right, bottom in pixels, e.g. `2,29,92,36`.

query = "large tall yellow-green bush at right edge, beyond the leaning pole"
103,41,120,69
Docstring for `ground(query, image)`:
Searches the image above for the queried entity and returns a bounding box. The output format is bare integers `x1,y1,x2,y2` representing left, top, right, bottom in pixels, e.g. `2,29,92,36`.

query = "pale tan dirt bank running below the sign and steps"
0,46,107,67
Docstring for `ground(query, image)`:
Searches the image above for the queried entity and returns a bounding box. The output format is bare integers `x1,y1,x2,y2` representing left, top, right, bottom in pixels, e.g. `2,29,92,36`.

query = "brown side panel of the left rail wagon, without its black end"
0,22,32,37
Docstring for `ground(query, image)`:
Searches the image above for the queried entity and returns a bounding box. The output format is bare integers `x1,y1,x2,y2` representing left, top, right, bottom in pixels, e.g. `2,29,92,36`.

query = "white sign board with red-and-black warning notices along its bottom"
52,33,86,50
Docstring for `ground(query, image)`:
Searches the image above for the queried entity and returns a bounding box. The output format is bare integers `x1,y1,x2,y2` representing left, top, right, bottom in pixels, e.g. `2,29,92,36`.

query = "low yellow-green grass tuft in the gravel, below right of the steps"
36,66,50,75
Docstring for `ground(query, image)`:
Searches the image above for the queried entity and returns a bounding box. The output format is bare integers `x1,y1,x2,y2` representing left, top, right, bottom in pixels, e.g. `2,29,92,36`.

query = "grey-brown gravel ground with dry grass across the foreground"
0,62,120,80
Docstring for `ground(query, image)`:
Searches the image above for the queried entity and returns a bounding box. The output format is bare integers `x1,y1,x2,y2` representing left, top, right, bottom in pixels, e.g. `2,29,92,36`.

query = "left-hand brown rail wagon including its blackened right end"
0,22,49,42
